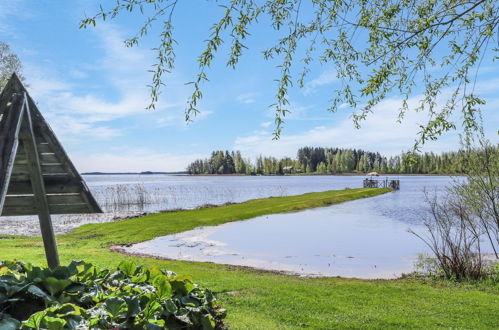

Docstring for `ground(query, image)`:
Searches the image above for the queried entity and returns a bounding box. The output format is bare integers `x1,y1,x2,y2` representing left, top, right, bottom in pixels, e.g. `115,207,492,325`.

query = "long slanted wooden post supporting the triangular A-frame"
21,93,59,268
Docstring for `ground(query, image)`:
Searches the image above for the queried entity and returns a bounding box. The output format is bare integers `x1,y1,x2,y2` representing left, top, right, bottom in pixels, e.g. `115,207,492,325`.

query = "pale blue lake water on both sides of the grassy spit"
0,175,470,278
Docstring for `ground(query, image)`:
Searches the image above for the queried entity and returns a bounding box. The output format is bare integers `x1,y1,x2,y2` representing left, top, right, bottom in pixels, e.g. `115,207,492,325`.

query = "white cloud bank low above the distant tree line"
234,89,499,157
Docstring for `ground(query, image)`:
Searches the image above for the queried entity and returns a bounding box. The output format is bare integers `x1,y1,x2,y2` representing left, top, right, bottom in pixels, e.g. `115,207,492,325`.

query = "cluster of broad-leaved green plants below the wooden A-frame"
0,261,225,330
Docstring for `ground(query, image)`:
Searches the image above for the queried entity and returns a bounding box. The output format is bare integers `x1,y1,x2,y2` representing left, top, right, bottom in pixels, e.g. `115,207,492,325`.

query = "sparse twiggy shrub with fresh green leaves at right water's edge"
411,136,499,280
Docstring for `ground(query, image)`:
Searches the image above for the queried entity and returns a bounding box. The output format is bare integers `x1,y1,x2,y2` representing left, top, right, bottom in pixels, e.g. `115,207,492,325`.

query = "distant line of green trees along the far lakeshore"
187,146,492,175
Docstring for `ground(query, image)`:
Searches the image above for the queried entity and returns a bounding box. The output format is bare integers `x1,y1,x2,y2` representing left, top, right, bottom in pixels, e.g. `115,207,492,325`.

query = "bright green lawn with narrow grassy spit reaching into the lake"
0,189,499,329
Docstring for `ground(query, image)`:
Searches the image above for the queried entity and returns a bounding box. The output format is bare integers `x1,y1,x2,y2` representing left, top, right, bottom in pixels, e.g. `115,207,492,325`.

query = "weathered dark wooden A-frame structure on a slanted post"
0,74,102,268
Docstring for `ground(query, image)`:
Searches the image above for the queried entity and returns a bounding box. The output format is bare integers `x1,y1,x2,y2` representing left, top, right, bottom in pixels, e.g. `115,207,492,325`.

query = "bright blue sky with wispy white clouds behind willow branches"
0,0,499,172
